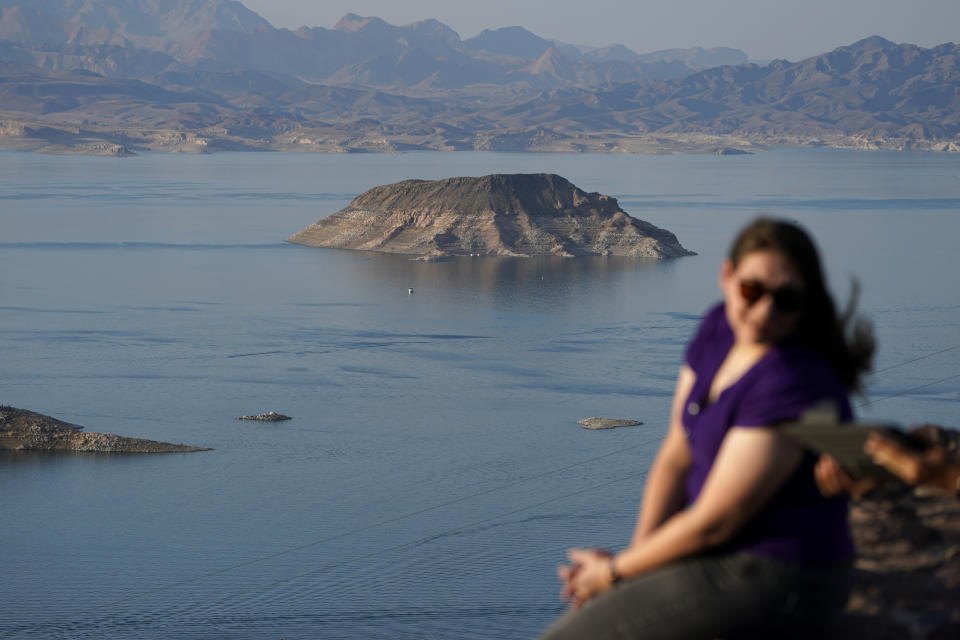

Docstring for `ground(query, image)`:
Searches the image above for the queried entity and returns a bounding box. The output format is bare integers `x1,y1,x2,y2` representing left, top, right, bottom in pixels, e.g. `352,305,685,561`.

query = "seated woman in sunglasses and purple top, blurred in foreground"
543,218,873,640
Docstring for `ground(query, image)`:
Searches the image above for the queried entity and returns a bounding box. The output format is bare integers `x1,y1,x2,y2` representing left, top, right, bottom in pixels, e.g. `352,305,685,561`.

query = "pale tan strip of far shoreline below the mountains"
0,116,960,157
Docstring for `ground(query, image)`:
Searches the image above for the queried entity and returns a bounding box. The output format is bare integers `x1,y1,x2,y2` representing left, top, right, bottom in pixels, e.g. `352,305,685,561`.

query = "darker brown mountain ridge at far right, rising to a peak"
568,36,960,141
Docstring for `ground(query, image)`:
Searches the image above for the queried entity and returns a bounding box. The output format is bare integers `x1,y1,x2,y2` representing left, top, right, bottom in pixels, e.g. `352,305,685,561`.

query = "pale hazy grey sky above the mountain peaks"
241,0,960,60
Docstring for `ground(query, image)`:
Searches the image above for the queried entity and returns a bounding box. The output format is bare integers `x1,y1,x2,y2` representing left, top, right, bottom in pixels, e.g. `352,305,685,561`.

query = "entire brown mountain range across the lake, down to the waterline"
0,0,960,154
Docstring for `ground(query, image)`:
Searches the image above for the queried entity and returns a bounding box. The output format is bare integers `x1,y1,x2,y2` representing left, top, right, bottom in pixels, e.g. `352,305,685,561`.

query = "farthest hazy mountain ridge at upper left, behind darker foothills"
0,0,746,90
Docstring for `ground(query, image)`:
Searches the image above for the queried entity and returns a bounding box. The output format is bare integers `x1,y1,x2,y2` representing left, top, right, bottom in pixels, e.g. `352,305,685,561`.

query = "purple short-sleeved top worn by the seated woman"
683,304,853,566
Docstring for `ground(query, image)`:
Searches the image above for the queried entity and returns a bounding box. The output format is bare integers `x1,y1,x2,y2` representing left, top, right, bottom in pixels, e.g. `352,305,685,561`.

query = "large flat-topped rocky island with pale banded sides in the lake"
287,173,694,259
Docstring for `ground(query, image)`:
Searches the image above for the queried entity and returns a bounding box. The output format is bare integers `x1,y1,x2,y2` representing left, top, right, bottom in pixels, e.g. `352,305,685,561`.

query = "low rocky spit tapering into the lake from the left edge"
0,406,210,453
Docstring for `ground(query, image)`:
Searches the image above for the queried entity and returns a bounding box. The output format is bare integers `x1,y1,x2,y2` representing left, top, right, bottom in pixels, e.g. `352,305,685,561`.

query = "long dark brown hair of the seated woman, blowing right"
730,218,876,389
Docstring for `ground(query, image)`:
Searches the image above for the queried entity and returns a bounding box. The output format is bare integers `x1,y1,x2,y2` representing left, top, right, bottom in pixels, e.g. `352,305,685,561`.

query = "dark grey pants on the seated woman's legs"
541,553,849,640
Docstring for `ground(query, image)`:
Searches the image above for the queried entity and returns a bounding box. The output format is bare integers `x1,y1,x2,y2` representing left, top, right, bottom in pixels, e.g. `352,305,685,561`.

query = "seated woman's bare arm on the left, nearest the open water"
630,365,696,546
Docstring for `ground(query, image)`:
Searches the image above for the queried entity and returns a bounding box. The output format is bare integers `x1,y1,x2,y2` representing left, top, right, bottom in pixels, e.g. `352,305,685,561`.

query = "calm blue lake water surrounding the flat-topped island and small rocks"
0,150,960,640
